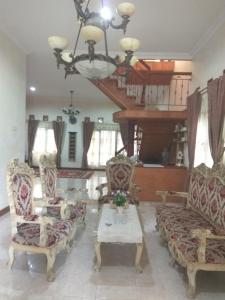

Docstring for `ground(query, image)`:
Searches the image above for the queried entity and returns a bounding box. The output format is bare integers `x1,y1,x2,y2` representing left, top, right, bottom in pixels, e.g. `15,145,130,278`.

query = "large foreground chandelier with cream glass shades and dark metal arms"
48,0,140,79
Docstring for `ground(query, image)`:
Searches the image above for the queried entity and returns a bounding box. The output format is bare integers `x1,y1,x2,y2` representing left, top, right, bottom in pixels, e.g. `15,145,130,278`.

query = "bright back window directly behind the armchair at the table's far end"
88,124,123,167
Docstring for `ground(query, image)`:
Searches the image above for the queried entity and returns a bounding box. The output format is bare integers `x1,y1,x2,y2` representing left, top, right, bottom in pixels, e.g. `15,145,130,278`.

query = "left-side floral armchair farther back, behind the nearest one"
39,155,86,224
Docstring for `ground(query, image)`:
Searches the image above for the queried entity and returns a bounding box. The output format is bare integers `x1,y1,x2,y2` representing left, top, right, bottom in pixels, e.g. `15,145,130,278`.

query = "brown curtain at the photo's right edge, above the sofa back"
208,75,225,163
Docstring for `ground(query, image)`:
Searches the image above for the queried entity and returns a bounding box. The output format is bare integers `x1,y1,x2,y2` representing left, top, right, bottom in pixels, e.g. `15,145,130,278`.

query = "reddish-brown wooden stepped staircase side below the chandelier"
90,78,137,110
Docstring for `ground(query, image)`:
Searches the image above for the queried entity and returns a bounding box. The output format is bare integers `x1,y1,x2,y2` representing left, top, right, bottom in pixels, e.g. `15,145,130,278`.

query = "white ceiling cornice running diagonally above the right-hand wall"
190,7,225,58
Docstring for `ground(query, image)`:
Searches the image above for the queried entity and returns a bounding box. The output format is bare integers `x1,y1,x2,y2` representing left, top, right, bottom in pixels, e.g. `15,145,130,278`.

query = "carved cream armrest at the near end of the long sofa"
191,228,225,263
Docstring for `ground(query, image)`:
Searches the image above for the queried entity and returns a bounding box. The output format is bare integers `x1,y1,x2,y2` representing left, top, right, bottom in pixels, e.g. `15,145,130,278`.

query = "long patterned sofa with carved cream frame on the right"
156,164,225,297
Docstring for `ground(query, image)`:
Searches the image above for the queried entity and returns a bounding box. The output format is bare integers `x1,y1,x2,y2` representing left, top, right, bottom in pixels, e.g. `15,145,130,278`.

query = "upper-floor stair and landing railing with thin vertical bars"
110,72,191,111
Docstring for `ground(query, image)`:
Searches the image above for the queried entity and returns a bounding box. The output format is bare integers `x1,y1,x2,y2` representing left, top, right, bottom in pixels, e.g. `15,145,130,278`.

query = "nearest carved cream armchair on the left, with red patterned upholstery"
7,159,72,281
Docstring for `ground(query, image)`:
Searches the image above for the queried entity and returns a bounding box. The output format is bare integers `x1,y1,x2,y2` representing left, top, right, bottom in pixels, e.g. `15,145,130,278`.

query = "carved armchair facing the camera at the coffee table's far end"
96,155,141,204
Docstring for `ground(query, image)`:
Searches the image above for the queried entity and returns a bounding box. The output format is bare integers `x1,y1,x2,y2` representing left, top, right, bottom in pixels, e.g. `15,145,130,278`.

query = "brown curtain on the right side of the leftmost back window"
52,121,65,168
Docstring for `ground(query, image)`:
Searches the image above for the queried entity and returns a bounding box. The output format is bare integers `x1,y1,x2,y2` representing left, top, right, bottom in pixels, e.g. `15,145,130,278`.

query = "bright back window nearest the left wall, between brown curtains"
32,122,57,166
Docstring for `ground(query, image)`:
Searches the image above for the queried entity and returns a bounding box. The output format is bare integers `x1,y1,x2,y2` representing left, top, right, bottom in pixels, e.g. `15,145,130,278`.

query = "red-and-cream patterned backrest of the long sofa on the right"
187,164,225,229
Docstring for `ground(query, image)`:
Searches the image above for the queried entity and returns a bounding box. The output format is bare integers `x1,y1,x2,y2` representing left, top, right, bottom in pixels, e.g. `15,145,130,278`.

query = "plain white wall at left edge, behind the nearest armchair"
0,32,26,209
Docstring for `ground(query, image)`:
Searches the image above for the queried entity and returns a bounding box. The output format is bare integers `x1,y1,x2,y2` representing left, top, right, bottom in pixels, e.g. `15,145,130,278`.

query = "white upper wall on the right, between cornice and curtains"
192,24,225,90
